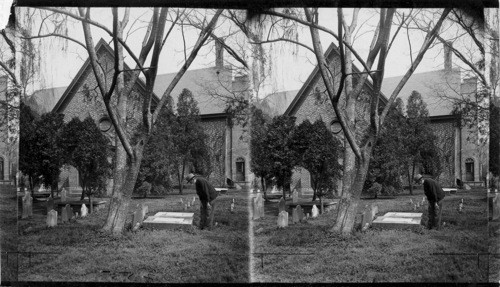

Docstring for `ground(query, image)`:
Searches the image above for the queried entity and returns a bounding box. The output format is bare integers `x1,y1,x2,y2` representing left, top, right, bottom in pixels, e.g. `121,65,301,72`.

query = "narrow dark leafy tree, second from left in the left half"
31,112,67,198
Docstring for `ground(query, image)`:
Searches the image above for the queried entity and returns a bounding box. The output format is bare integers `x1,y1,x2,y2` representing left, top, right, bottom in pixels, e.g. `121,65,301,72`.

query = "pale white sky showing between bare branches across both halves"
17,8,474,95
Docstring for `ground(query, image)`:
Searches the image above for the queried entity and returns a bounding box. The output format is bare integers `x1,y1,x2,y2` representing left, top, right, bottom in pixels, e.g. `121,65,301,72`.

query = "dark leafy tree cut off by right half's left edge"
250,106,271,197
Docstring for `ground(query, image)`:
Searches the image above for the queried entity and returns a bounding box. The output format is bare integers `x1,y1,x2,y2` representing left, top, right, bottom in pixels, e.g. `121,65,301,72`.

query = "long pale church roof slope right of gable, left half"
153,67,233,115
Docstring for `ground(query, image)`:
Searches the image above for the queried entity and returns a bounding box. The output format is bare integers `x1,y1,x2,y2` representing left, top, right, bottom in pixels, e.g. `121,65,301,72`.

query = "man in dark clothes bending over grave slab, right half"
415,174,445,229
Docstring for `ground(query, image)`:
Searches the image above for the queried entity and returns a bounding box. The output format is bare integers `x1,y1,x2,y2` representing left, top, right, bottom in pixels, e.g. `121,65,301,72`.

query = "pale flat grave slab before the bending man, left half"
142,212,194,229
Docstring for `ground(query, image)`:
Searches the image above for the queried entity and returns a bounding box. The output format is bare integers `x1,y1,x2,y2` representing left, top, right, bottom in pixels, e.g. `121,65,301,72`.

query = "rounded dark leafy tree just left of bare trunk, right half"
294,119,342,201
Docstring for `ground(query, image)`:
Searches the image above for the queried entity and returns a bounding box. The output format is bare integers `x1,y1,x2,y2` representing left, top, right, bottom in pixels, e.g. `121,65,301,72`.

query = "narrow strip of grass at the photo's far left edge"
0,185,17,285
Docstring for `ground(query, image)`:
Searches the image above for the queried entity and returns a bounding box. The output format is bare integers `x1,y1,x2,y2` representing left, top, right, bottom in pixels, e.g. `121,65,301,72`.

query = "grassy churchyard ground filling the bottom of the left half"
19,190,249,283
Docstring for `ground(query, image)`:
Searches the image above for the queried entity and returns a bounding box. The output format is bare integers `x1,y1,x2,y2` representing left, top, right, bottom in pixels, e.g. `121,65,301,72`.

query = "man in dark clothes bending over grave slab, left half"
186,173,218,229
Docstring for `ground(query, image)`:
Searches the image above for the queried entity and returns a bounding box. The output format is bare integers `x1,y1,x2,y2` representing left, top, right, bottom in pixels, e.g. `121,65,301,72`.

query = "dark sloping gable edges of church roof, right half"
285,43,388,115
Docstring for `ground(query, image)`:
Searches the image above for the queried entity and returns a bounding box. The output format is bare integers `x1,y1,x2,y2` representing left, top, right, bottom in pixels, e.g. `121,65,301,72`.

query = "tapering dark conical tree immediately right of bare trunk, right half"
364,98,408,197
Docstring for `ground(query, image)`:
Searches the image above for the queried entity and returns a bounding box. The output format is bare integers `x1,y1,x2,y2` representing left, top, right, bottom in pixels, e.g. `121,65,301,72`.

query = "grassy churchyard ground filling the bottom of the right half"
251,190,488,282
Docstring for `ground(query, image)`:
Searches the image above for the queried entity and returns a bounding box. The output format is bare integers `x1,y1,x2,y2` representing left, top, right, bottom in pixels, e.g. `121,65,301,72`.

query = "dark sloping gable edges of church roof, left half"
52,38,158,112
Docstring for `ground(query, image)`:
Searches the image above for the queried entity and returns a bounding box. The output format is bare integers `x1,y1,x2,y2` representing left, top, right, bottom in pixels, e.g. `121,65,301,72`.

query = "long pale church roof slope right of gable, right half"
381,68,461,117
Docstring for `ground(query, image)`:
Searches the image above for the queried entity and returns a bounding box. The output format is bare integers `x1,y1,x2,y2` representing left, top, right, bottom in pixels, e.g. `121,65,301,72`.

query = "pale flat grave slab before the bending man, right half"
372,212,422,229
